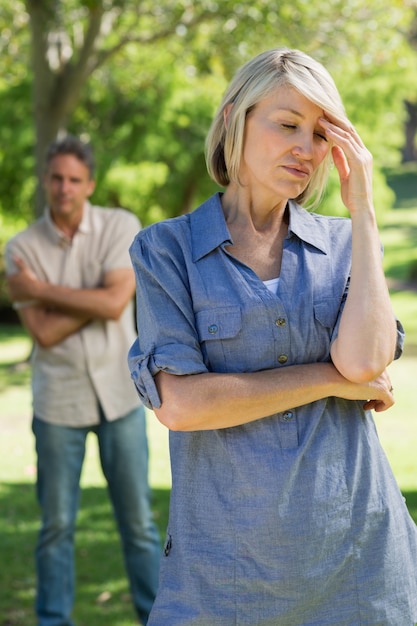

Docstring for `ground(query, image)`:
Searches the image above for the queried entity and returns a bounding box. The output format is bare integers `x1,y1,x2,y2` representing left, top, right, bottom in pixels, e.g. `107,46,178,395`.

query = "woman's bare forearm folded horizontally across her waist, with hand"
154,363,394,431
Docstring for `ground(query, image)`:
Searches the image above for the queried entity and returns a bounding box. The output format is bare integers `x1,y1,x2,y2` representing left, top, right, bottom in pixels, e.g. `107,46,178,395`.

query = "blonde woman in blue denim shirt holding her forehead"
129,49,417,626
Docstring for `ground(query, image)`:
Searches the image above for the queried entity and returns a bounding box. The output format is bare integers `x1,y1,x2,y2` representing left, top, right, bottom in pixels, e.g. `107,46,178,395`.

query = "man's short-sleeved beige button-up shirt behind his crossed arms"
6,203,140,426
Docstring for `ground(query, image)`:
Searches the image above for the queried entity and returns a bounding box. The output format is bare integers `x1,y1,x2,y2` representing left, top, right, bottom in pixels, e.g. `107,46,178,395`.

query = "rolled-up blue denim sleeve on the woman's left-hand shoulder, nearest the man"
128,224,207,408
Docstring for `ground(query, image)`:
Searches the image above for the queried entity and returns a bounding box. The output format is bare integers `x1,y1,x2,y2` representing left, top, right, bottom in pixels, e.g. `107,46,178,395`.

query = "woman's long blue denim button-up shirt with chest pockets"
129,195,417,626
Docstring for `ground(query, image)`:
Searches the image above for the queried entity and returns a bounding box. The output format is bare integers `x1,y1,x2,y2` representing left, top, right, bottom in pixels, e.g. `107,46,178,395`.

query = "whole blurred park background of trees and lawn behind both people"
0,0,417,626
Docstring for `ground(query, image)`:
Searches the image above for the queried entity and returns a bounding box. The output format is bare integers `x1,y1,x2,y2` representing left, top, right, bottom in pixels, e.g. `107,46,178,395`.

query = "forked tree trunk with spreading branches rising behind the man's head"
25,0,221,212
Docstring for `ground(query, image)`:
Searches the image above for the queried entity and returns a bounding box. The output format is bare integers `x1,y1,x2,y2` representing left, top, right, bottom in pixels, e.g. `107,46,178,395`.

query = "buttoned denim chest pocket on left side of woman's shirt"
196,306,242,372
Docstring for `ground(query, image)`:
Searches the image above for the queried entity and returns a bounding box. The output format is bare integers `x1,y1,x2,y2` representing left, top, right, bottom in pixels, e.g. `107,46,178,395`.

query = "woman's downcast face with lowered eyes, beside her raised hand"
239,86,330,202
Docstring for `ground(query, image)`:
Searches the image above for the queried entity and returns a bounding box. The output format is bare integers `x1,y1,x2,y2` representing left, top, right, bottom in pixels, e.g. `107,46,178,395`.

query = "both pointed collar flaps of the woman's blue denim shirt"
190,193,329,262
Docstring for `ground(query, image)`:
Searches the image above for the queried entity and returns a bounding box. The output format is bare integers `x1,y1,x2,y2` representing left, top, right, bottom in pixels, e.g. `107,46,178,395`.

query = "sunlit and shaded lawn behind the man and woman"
0,163,417,626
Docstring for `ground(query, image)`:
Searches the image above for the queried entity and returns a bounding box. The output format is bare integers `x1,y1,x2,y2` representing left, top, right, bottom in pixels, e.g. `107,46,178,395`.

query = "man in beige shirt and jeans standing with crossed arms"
6,136,160,626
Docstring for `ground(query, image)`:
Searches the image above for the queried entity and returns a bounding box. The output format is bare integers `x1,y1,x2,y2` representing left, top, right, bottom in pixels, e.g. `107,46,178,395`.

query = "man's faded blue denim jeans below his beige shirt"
32,407,160,626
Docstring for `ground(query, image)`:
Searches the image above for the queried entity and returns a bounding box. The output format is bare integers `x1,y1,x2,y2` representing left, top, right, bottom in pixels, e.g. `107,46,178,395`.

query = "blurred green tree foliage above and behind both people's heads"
0,0,415,229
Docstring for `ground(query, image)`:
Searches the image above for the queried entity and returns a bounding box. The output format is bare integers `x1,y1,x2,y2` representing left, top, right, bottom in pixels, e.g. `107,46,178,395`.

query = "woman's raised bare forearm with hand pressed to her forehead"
323,120,397,382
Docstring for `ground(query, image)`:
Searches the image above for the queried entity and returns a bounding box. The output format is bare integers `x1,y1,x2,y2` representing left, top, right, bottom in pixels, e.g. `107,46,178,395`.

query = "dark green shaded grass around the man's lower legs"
0,483,169,626
